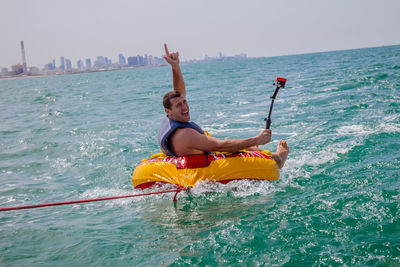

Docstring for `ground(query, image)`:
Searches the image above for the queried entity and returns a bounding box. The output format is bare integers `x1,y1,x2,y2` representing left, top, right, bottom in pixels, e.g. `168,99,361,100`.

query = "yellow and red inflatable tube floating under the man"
132,150,279,189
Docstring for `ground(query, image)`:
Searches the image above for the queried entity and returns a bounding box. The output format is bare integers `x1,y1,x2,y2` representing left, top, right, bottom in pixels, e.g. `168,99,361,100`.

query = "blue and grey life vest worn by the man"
158,116,204,157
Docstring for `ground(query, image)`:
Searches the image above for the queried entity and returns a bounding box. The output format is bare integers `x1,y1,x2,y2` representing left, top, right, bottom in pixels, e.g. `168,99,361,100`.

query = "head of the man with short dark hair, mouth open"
163,91,190,122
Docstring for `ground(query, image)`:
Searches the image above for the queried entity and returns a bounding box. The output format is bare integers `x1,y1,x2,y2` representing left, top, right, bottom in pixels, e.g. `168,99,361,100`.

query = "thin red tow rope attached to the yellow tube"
0,186,186,212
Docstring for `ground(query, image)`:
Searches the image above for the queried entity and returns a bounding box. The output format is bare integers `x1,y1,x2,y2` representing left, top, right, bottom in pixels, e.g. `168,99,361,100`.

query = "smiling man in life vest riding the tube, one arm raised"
158,44,289,168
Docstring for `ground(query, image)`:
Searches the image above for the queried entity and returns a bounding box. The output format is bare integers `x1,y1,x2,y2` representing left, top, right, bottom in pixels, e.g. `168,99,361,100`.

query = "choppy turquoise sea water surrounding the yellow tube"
0,46,400,266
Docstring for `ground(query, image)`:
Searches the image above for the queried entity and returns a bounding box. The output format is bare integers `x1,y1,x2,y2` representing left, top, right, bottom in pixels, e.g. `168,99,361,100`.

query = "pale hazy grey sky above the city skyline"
0,0,400,68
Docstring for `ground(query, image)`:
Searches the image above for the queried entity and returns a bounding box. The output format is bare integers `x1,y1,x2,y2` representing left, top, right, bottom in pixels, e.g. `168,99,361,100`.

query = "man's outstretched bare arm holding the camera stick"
172,128,271,156
